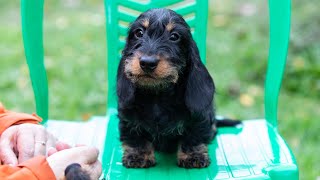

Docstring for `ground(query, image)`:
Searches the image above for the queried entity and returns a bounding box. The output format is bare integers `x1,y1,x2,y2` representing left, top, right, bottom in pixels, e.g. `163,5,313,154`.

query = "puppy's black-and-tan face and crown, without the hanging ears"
122,9,192,88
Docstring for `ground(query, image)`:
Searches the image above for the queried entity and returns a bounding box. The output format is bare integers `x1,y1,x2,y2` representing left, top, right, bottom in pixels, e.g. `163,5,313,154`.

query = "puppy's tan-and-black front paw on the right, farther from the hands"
178,144,210,168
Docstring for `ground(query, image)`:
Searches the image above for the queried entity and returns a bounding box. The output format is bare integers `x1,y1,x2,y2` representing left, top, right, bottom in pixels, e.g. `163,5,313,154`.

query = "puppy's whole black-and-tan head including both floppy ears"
117,9,215,112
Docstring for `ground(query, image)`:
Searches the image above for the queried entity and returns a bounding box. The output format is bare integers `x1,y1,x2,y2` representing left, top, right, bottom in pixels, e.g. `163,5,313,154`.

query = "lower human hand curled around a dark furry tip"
47,146,102,179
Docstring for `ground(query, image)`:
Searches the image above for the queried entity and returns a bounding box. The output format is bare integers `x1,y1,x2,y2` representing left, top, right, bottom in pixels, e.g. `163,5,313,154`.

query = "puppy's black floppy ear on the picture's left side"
117,58,135,108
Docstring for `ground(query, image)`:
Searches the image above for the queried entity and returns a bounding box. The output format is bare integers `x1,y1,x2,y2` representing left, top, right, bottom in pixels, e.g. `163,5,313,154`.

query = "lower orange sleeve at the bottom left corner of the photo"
0,156,56,180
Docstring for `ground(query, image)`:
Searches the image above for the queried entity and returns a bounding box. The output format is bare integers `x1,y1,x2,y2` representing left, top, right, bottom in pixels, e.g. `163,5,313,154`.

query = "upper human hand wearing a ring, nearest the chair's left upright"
0,124,57,165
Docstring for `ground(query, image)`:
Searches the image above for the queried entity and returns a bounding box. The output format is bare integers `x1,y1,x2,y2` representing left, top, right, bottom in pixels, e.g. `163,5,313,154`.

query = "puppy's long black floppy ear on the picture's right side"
185,40,215,112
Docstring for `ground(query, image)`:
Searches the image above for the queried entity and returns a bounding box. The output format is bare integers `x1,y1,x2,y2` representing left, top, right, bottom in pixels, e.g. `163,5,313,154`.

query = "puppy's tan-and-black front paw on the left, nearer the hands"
122,145,156,168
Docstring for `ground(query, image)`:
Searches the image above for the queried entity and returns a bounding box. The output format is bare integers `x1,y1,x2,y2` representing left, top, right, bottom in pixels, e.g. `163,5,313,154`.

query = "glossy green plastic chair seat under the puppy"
48,111,298,180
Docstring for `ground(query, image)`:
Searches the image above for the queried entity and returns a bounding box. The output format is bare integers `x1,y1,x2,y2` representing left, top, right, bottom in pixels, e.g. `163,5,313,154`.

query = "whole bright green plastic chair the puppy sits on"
21,0,299,180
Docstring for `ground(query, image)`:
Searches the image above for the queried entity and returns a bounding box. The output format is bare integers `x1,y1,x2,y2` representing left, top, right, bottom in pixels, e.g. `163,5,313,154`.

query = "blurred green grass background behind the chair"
0,0,320,179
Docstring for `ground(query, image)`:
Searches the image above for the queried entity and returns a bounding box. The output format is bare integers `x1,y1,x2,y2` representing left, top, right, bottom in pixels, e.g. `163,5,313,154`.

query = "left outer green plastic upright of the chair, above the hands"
21,0,49,123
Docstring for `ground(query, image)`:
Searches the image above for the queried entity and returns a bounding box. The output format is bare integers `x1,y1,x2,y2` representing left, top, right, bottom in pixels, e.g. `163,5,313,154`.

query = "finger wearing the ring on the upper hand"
34,126,47,156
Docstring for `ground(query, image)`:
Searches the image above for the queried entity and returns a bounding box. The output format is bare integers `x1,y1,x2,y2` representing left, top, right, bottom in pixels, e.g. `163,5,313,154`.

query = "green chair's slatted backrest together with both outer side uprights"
21,0,290,127
